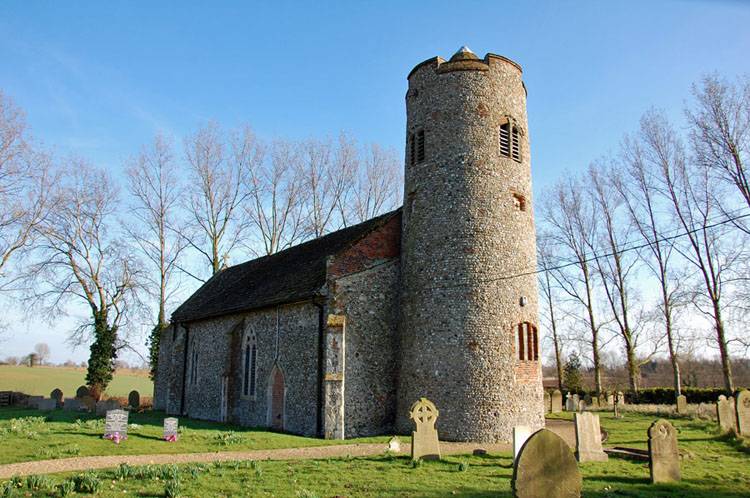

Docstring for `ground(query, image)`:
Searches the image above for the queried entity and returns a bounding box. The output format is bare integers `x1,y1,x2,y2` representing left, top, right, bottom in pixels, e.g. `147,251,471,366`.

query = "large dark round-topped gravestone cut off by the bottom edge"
511,429,582,498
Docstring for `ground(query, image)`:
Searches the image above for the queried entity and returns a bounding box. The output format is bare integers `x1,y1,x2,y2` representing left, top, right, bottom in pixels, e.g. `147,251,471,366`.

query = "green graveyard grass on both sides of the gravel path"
0,410,750,498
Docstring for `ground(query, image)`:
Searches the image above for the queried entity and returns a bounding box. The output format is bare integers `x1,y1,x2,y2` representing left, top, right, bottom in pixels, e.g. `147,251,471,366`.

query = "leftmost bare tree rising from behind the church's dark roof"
182,123,247,280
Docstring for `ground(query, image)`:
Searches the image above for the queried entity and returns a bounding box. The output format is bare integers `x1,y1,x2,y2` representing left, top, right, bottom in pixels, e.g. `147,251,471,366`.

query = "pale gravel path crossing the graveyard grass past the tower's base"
0,420,575,479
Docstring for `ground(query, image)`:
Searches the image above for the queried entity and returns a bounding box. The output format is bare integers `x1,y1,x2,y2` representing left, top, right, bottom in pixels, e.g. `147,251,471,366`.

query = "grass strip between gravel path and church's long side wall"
0,408,388,464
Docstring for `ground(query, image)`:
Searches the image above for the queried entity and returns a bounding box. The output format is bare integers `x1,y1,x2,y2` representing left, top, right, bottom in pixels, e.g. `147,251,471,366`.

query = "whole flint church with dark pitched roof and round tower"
154,47,544,442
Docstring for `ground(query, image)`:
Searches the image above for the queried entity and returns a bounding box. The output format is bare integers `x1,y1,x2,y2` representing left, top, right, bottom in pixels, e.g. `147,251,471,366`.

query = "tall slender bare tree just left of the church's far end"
126,135,186,377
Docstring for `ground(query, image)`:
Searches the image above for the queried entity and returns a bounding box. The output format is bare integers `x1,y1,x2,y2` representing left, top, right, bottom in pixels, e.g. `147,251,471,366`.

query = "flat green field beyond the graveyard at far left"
0,365,154,397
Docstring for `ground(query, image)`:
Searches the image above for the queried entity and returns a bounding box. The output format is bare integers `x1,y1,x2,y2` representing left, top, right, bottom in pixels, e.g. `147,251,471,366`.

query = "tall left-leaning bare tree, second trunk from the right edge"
613,122,682,396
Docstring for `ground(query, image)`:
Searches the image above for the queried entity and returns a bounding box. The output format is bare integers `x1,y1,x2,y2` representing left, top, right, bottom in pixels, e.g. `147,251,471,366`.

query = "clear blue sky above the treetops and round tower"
0,0,750,360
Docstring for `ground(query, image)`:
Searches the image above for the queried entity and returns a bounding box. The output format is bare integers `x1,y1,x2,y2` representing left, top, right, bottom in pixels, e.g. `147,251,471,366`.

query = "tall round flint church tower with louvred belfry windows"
397,47,544,442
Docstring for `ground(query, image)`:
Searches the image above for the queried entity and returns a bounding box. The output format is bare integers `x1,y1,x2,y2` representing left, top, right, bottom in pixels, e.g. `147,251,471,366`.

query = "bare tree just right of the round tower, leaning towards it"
542,178,602,394
